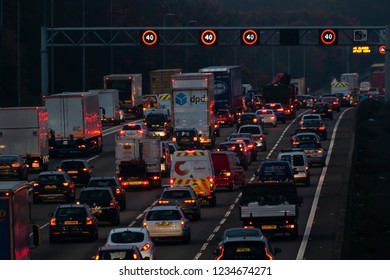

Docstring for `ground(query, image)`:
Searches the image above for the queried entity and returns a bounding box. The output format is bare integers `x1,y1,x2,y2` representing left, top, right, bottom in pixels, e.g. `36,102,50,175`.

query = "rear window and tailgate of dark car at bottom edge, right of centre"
221,241,269,260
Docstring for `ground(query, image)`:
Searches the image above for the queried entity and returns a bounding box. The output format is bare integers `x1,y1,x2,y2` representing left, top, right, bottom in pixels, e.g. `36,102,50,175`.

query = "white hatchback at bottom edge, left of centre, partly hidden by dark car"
104,227,156,260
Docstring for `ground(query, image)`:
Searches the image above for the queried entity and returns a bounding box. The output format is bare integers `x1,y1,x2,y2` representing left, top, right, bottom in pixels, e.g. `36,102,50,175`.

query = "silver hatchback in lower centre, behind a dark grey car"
142,205,191,243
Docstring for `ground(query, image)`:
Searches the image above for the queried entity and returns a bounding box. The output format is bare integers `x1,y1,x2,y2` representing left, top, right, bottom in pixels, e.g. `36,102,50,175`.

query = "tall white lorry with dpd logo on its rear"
171,73,216,148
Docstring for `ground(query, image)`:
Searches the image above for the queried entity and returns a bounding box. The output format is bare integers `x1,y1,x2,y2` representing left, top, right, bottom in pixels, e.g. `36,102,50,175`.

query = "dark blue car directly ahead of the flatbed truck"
255,160,295,185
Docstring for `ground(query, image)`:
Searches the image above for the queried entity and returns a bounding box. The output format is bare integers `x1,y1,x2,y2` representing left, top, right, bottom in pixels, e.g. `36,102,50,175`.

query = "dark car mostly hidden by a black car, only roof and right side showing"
86,176,126,210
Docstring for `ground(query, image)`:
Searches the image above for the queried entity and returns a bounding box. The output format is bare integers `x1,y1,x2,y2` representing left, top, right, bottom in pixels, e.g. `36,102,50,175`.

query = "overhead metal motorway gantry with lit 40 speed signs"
41,26,390,101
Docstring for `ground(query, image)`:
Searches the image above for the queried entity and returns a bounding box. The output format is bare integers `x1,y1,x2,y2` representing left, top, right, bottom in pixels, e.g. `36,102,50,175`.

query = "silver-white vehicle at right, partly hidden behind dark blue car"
277,149,310,186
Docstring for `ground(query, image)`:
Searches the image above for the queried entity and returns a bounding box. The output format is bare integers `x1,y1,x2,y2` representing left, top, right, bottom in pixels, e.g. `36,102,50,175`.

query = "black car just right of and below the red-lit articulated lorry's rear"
57,159,93,186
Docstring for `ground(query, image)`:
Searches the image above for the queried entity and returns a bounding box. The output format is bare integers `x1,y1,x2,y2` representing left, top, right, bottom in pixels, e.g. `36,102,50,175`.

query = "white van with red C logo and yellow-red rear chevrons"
169,150,216,207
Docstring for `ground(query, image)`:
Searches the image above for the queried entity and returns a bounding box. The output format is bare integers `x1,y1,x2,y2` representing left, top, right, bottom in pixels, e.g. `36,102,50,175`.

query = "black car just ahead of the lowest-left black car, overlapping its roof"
78,187,120,226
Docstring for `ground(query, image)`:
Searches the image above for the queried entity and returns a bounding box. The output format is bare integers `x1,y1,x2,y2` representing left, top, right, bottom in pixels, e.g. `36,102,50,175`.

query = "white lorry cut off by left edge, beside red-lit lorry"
0,107,49,171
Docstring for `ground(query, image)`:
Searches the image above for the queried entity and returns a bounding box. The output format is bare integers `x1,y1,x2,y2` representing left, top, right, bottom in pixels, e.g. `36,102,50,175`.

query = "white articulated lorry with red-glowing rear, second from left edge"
44,92,103,157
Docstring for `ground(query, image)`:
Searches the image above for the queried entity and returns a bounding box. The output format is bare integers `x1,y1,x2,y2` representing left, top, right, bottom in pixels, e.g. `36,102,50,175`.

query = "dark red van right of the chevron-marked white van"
211,151,245,191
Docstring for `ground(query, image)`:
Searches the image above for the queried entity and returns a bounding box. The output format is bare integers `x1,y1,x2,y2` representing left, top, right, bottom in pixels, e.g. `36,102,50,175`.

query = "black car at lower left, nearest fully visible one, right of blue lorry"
49,204,99,243
